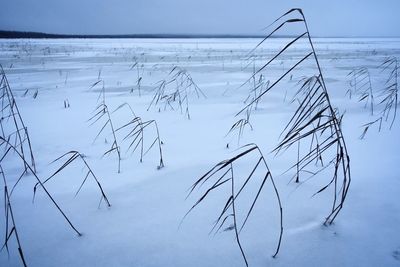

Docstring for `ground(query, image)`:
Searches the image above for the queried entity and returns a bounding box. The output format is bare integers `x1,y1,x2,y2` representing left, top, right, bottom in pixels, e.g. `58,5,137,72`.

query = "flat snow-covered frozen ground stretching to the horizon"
0,38,400,267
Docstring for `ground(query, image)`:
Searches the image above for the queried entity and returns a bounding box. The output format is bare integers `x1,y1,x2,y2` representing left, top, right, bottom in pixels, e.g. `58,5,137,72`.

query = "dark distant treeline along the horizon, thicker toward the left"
0,31,272,39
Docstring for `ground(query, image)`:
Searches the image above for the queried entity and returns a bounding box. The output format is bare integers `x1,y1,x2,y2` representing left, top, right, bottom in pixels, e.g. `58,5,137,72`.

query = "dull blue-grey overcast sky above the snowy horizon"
0,0,400,36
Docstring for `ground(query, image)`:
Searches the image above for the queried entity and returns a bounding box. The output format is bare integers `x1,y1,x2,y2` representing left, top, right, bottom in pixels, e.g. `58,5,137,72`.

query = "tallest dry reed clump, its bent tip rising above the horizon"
237,8,351,224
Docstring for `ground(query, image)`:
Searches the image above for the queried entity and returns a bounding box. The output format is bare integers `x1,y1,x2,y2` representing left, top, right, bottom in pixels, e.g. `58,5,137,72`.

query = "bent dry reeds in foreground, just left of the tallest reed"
182,144,283,266
